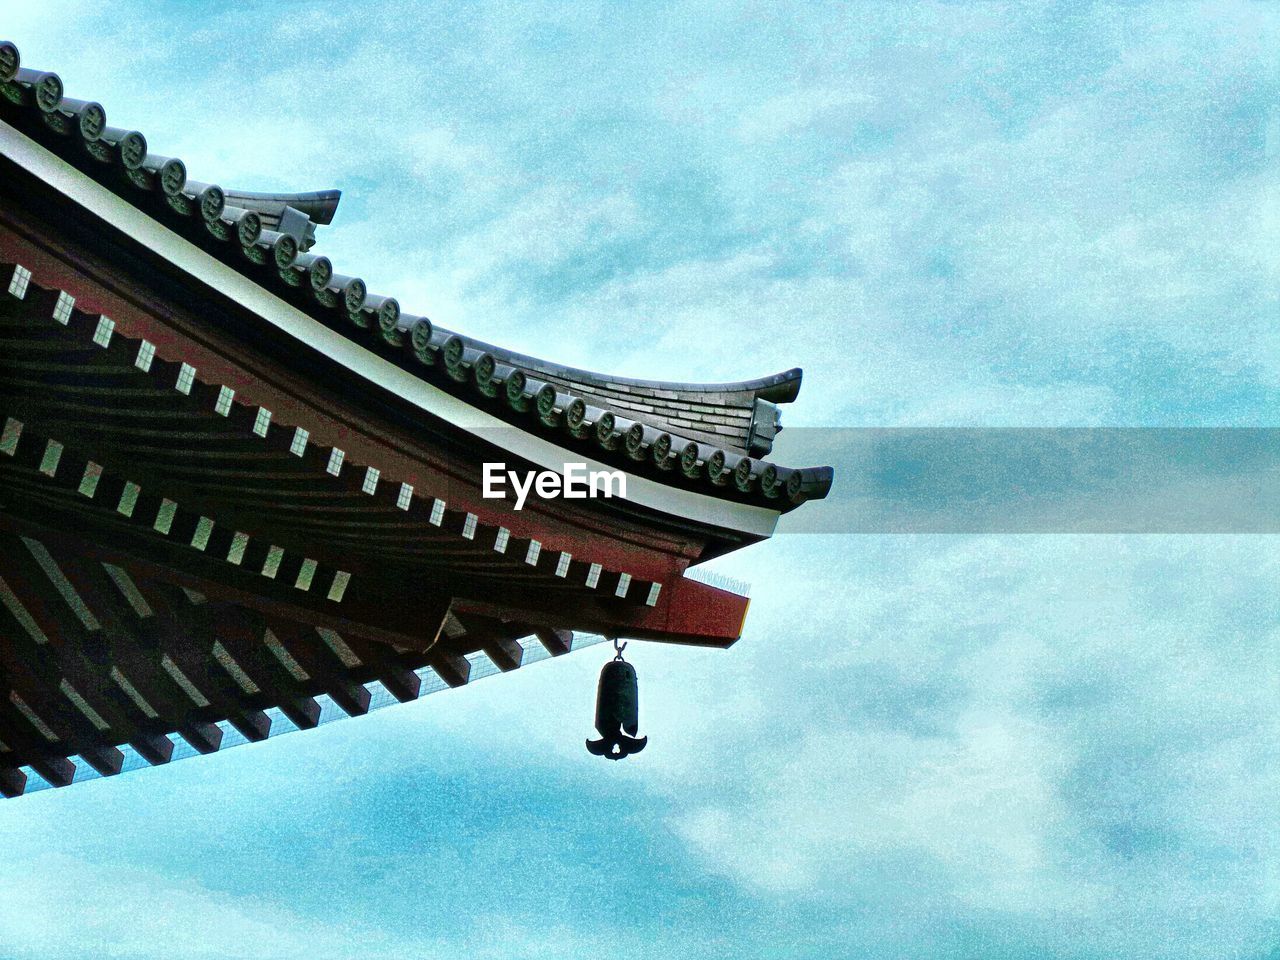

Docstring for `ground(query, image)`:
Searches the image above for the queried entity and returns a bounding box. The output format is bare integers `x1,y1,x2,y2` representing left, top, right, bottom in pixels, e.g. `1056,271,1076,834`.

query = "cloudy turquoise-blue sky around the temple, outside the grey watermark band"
0,0,1280,960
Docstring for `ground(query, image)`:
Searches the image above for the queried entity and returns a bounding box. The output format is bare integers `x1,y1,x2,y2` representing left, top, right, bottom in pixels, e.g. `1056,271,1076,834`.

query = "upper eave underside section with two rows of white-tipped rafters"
0,280,740,649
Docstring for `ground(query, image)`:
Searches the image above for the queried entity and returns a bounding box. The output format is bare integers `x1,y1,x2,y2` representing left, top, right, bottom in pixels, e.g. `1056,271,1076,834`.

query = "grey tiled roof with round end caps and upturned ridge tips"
0,42,832,511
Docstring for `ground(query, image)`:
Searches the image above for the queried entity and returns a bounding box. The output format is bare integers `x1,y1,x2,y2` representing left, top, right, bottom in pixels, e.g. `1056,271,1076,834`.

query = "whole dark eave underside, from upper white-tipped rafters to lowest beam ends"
0,284,747,796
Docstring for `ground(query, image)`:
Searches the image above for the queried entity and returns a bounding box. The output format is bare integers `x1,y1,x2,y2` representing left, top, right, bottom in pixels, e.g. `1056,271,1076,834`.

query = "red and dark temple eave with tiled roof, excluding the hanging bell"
0,42,832,796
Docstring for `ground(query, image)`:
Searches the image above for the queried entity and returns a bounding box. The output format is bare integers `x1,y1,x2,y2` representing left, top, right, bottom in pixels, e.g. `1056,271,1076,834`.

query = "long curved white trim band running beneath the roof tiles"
0,123,778,536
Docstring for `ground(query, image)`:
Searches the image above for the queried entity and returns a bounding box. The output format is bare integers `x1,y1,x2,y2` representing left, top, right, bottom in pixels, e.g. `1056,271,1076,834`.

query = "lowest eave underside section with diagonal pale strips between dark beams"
0,530,573,796
